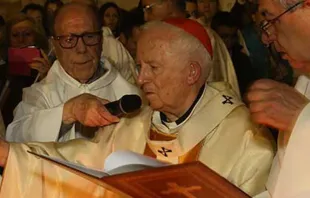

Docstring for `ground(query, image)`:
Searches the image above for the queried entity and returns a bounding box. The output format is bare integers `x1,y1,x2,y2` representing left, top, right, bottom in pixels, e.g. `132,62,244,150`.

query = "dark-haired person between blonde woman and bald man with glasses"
21,3,45,34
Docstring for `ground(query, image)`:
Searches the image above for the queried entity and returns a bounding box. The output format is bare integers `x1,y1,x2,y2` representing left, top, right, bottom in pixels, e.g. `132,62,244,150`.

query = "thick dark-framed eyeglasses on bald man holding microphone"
52,31,102,49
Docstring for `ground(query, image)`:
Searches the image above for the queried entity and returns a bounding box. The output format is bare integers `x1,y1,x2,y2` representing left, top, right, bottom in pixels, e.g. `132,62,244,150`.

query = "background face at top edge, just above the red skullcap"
197,0,218,20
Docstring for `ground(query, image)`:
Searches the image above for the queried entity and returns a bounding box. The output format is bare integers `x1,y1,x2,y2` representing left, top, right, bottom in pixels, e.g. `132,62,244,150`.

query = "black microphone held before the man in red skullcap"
104,95,142,117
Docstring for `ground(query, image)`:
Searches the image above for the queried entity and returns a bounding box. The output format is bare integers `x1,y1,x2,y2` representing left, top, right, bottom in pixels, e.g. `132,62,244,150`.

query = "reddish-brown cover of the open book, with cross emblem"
101,162,250,198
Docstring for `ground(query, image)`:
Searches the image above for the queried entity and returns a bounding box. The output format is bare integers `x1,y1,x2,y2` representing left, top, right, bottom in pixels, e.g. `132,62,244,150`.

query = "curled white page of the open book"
104,151,169,173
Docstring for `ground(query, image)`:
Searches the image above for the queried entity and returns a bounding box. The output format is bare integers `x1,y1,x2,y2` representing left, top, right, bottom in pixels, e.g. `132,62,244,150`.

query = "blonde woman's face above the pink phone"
10,21,35,48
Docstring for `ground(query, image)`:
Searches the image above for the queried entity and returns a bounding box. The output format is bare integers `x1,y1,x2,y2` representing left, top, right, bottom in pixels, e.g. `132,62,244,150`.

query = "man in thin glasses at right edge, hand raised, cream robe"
247,0,310,198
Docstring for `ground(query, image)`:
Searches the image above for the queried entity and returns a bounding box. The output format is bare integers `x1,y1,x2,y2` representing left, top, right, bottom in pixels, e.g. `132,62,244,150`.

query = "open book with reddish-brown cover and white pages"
30,151,250,198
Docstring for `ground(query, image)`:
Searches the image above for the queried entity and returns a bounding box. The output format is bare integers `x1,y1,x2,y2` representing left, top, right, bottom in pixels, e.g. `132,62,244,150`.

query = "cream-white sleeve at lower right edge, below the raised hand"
273,104,310,198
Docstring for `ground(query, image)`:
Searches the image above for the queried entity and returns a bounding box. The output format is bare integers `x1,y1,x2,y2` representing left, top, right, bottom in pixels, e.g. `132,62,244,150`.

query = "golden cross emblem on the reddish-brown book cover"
160,183,202,198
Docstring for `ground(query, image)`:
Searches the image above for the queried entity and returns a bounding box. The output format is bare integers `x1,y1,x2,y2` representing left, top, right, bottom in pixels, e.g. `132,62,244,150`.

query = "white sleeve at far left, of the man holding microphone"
6,88,63,142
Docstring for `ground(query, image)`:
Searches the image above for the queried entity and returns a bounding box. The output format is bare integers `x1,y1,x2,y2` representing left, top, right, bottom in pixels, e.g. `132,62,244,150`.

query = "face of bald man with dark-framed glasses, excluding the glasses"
53,11,102,83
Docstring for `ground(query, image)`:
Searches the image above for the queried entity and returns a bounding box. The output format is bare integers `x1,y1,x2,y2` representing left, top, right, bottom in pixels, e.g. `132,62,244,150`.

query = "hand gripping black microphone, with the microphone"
62,94,142,127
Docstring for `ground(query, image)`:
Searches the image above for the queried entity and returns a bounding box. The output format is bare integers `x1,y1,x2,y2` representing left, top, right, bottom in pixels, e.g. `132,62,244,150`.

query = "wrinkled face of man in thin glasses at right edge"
259,0,310,72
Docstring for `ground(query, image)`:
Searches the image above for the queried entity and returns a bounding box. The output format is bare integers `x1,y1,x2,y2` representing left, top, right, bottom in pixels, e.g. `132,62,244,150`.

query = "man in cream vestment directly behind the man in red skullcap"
142,0,240,95
